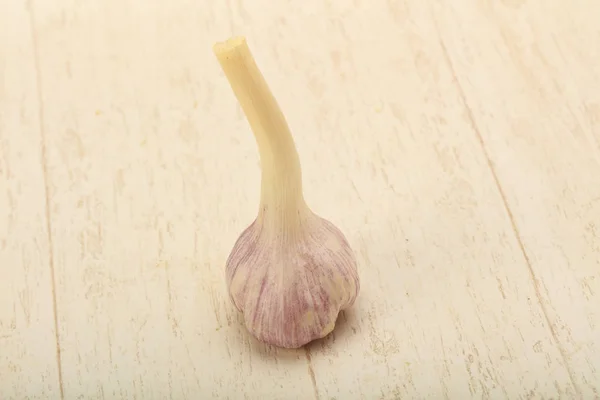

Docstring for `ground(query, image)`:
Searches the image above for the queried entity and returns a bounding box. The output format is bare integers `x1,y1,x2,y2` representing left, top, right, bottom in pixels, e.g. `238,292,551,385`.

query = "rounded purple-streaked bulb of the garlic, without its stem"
226,212,360,348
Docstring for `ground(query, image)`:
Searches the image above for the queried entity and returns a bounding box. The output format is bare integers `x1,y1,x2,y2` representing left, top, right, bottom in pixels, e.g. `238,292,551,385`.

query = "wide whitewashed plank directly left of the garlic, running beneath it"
30,0,311,399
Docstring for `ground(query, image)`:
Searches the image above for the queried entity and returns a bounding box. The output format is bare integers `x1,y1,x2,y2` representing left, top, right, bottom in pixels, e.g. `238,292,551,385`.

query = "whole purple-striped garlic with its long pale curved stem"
213,37,360,348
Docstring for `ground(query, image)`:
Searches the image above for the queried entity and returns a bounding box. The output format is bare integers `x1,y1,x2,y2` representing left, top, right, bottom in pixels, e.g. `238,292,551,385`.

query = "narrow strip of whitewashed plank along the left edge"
0,1,60,400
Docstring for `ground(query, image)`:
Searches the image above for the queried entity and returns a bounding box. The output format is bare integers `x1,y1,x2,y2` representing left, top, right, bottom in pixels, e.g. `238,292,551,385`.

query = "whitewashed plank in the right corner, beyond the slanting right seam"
438,1,600,398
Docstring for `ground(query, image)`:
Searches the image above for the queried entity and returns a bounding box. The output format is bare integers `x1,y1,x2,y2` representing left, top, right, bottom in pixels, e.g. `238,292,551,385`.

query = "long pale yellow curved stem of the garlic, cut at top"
213,37,307,227
